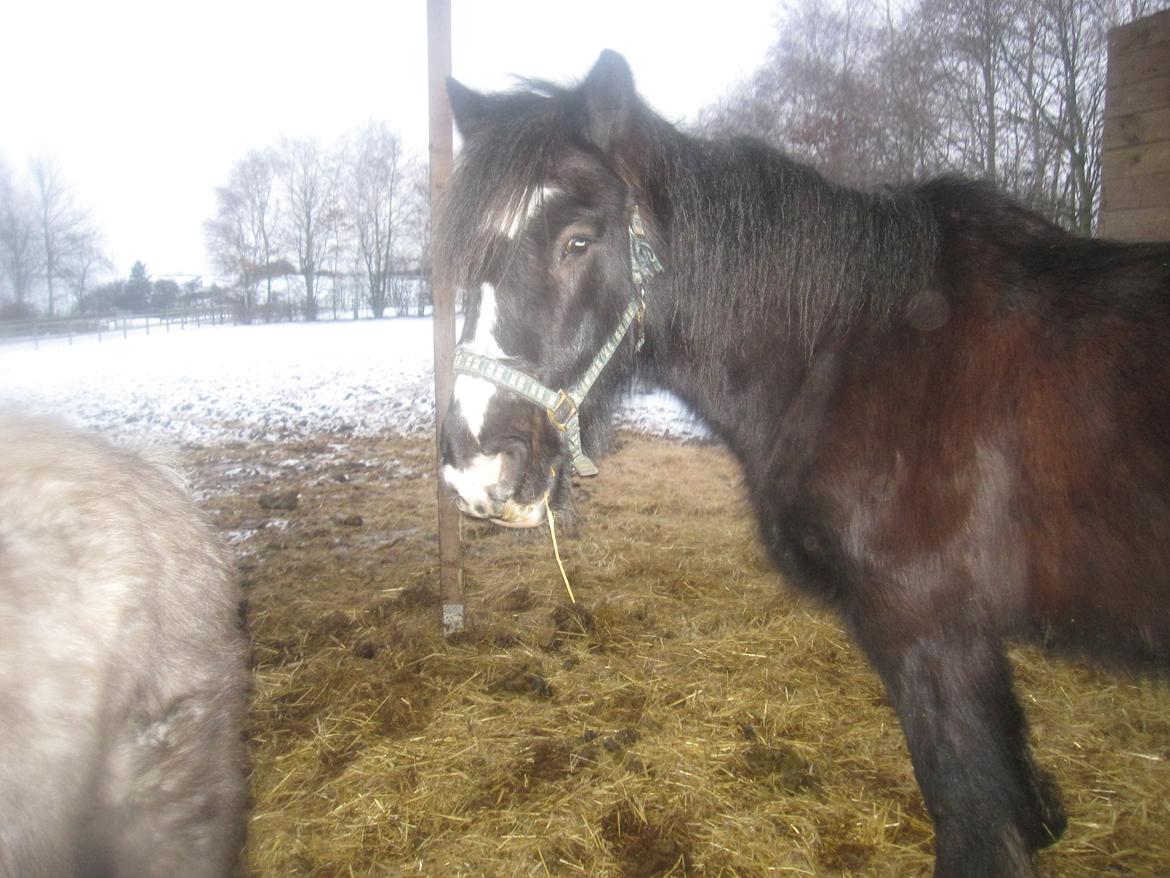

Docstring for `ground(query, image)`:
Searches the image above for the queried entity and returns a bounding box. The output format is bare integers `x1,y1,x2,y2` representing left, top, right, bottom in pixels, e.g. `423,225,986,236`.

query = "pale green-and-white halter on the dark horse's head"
455,205,663,475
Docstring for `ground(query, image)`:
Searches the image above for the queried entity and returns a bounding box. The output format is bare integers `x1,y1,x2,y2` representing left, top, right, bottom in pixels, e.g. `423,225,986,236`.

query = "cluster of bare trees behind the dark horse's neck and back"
700,0,1159,233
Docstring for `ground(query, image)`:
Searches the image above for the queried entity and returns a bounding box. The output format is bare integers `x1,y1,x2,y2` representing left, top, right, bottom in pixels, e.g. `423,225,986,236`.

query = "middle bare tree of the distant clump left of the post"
278,139,339,321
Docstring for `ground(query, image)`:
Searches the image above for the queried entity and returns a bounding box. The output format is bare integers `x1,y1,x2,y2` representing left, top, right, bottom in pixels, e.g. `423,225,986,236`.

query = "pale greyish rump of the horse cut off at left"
0,413,247,878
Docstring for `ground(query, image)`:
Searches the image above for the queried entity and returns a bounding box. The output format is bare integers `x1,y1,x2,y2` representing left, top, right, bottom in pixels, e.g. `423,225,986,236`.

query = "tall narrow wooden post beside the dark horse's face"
427,0,463,636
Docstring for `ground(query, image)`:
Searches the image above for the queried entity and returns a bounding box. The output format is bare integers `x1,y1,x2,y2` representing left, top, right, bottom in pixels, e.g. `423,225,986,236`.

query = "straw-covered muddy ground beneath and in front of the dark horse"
186,435,1170,878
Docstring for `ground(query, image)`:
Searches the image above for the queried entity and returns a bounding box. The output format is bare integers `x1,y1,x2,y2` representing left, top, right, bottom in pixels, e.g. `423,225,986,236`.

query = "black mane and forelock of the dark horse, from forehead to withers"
435,74,1066,351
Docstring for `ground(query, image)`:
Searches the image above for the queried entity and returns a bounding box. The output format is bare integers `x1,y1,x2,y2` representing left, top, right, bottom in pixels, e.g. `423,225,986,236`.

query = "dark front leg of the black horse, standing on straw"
861,619,1065,878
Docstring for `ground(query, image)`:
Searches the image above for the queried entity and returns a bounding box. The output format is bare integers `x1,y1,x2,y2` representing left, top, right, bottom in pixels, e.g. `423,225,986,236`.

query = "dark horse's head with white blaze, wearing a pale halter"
436,52,661,527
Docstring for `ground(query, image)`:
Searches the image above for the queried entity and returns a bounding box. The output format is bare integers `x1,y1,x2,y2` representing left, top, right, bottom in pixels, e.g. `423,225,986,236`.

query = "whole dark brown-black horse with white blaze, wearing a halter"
438,53,1170,878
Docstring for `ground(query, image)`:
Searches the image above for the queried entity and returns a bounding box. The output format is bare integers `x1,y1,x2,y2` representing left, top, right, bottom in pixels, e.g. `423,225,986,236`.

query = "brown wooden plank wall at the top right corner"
1097,9,1170,241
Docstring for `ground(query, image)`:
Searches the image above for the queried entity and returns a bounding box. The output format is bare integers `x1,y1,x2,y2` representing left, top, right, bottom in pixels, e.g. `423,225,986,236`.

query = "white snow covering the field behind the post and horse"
0,317,704,445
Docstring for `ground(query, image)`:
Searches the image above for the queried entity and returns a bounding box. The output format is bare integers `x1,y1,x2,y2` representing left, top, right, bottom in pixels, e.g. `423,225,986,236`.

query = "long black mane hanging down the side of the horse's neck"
652,126,937,347
